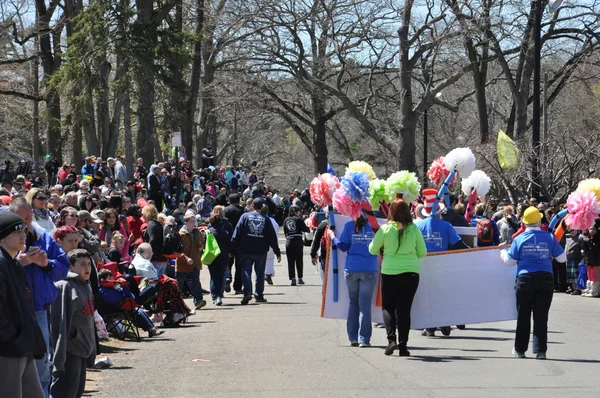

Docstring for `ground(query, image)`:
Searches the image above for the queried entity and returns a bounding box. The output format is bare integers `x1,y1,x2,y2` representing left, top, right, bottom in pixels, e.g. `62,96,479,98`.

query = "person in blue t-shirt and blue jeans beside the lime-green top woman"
328,216,379,347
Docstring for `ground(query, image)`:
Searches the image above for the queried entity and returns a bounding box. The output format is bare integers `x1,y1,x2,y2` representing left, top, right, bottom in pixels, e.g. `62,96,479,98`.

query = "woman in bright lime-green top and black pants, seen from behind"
369,199,427,357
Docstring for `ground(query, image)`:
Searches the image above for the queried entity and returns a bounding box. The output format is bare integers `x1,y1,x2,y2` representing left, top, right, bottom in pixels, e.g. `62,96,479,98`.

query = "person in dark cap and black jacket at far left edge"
0,212,46,398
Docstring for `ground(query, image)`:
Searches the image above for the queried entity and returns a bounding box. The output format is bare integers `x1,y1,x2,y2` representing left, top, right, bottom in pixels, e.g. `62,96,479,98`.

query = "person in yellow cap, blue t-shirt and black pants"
500,207,567,359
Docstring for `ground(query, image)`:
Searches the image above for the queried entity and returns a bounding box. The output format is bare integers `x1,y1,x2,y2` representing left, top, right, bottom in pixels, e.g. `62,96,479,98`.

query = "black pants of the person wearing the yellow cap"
515,272,554,353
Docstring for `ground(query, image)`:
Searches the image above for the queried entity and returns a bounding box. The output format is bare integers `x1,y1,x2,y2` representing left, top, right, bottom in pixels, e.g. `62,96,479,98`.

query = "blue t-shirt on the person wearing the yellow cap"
508,230,564,275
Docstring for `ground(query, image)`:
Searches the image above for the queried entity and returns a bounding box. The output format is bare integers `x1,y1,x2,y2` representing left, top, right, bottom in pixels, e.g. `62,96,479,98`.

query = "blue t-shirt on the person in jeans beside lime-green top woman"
334,221,378,272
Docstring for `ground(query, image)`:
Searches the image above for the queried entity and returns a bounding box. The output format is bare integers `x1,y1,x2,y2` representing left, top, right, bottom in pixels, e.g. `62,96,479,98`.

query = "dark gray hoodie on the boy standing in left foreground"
51,271,96,372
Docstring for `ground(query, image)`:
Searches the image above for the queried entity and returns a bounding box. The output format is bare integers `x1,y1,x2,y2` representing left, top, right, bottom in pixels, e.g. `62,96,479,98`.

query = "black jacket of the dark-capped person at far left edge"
0,248,46,359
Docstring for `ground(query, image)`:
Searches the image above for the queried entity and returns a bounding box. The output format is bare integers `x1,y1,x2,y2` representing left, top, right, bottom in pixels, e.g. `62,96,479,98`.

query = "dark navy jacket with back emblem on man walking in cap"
232,211,281,256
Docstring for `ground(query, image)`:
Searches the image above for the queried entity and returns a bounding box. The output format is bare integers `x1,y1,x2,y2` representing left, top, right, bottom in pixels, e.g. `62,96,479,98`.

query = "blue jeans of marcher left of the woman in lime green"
344,272,377,343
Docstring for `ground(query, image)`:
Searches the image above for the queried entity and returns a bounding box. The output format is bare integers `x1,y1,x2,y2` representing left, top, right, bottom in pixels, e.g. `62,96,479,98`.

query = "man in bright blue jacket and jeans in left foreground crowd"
10,198,69,397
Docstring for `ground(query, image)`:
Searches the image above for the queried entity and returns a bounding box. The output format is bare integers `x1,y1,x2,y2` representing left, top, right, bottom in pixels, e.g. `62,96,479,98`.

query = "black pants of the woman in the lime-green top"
381,272,419,347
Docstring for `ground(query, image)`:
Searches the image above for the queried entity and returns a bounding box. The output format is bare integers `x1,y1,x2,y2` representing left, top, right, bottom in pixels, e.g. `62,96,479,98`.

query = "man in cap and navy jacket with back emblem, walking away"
232,198,281,305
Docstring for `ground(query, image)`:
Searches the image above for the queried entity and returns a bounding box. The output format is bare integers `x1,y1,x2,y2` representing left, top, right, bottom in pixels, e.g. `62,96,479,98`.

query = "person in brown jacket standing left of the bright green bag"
175,214,206,310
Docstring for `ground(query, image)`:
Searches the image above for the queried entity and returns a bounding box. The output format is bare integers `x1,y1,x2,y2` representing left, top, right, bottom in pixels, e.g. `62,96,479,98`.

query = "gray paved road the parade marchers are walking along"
91,232,600,398
